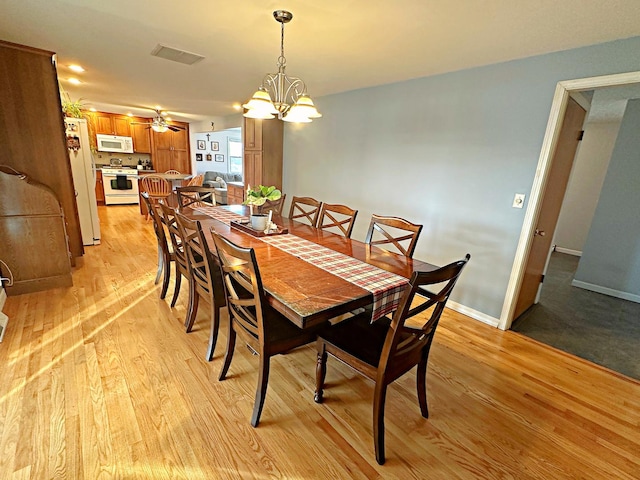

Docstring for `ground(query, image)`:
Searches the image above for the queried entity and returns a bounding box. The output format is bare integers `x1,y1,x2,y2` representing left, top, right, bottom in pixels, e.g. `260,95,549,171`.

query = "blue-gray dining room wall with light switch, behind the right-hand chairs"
284,37,640,318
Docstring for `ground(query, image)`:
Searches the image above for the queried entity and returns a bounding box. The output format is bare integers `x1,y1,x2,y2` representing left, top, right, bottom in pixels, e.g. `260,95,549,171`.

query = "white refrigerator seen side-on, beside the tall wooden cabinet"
64,118,100,245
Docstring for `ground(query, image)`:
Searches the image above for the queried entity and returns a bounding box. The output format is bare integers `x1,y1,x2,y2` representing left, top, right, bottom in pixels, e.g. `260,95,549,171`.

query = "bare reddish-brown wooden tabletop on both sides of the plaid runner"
181,205,437,328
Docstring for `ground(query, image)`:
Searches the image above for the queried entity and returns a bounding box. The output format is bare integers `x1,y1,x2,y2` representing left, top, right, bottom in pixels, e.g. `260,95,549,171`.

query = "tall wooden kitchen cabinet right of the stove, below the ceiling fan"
151,122,191,173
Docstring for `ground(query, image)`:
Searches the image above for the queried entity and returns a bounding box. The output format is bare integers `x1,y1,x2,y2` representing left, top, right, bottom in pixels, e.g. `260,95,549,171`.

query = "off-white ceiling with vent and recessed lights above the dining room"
0,0,640,121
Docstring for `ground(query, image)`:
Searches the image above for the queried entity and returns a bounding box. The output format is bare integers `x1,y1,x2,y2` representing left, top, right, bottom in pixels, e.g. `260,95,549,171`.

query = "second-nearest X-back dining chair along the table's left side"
176,213,226,362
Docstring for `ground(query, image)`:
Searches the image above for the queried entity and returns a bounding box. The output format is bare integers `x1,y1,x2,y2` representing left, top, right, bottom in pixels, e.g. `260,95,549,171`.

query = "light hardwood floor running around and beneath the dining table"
0,206,640,479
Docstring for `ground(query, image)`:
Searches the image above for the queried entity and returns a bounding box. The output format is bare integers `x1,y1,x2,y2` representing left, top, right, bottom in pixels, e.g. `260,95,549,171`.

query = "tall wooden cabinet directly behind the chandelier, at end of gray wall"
243,117,284,189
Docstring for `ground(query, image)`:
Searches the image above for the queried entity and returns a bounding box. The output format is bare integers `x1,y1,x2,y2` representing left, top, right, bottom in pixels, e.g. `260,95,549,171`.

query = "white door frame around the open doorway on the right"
498,72,640,330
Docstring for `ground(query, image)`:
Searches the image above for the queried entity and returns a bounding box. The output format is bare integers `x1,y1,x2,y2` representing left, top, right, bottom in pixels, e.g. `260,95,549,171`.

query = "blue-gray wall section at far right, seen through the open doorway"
575,100,640,300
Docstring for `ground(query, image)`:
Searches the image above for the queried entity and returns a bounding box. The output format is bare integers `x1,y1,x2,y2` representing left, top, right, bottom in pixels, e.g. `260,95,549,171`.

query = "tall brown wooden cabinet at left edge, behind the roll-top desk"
0,41,84,274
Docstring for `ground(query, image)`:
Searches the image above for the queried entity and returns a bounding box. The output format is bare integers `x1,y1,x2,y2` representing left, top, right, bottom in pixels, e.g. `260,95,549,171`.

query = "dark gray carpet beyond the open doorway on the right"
512,252,640,380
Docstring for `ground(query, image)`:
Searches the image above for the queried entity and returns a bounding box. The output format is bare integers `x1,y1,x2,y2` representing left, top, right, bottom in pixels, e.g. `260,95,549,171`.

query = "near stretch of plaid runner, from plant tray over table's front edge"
260,234,409,322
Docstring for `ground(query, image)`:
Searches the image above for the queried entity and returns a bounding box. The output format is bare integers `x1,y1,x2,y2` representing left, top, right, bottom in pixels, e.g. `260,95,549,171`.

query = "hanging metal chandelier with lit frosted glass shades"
243,10,322,123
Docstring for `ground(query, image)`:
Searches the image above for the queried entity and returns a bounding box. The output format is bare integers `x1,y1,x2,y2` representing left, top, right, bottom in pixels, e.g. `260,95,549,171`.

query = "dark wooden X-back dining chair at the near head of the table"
314,254,471,465
